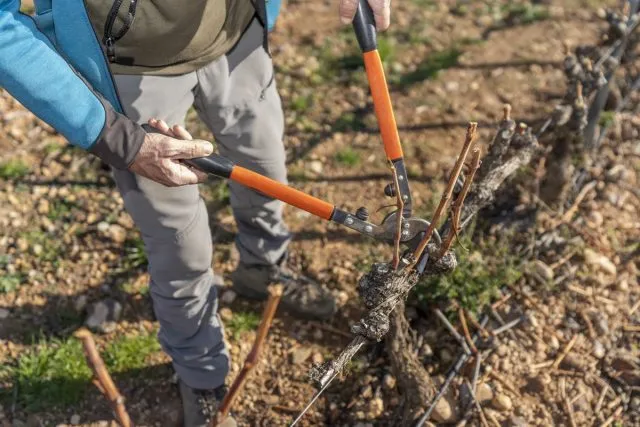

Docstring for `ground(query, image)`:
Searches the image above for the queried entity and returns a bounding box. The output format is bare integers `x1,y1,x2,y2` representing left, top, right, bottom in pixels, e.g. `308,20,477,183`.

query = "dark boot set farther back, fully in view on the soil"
231,254,336,320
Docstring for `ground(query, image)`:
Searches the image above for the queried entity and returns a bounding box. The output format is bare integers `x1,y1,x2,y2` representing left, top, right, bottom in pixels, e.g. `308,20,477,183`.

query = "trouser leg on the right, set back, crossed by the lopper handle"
190,20,290,265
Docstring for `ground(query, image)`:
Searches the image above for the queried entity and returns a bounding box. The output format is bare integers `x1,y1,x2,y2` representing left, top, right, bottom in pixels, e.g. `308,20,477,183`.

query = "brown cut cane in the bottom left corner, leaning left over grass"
74,328,133,427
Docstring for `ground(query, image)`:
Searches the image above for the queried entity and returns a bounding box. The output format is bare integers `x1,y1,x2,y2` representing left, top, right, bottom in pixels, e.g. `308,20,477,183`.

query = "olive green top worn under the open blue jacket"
85,0,255,75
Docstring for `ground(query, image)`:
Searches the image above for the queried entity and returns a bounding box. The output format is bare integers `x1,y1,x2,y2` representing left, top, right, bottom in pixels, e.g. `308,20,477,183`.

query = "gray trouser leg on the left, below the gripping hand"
114,73,229,389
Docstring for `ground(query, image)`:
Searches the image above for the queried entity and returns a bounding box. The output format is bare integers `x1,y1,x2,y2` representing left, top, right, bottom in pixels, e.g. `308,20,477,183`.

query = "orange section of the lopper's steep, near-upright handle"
363,50,403,161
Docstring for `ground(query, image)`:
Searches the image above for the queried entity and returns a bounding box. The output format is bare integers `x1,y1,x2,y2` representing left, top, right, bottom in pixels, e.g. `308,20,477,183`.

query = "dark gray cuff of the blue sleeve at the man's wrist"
89,98,147,169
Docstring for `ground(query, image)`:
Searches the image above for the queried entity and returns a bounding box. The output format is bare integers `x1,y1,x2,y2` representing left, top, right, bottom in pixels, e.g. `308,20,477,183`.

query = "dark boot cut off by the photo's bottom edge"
179,380,237,427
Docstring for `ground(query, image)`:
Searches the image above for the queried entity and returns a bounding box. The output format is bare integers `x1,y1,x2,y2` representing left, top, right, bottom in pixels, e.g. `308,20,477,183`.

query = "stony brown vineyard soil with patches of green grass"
0,0,640,426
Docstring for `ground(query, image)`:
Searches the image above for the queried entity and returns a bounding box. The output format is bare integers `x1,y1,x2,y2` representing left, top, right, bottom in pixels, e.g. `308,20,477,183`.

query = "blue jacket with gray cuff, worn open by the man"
0,0,280,169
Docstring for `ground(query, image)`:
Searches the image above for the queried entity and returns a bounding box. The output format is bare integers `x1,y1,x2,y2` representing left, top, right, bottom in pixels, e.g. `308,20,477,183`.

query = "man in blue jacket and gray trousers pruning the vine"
0,0,390,426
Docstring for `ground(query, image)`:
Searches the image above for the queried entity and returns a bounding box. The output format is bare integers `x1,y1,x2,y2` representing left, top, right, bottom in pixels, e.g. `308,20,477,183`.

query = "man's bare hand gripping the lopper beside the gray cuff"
129,119,213,187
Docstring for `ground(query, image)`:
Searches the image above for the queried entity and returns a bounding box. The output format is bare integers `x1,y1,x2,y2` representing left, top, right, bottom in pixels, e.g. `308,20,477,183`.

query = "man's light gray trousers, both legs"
114,20,290,389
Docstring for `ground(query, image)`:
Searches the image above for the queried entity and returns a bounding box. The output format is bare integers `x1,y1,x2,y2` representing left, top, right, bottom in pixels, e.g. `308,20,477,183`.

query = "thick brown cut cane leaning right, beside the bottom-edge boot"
215,285,283,427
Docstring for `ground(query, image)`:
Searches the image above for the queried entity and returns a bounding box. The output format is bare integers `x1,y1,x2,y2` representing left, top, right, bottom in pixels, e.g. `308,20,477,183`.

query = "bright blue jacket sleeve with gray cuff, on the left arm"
0,0,144,168
